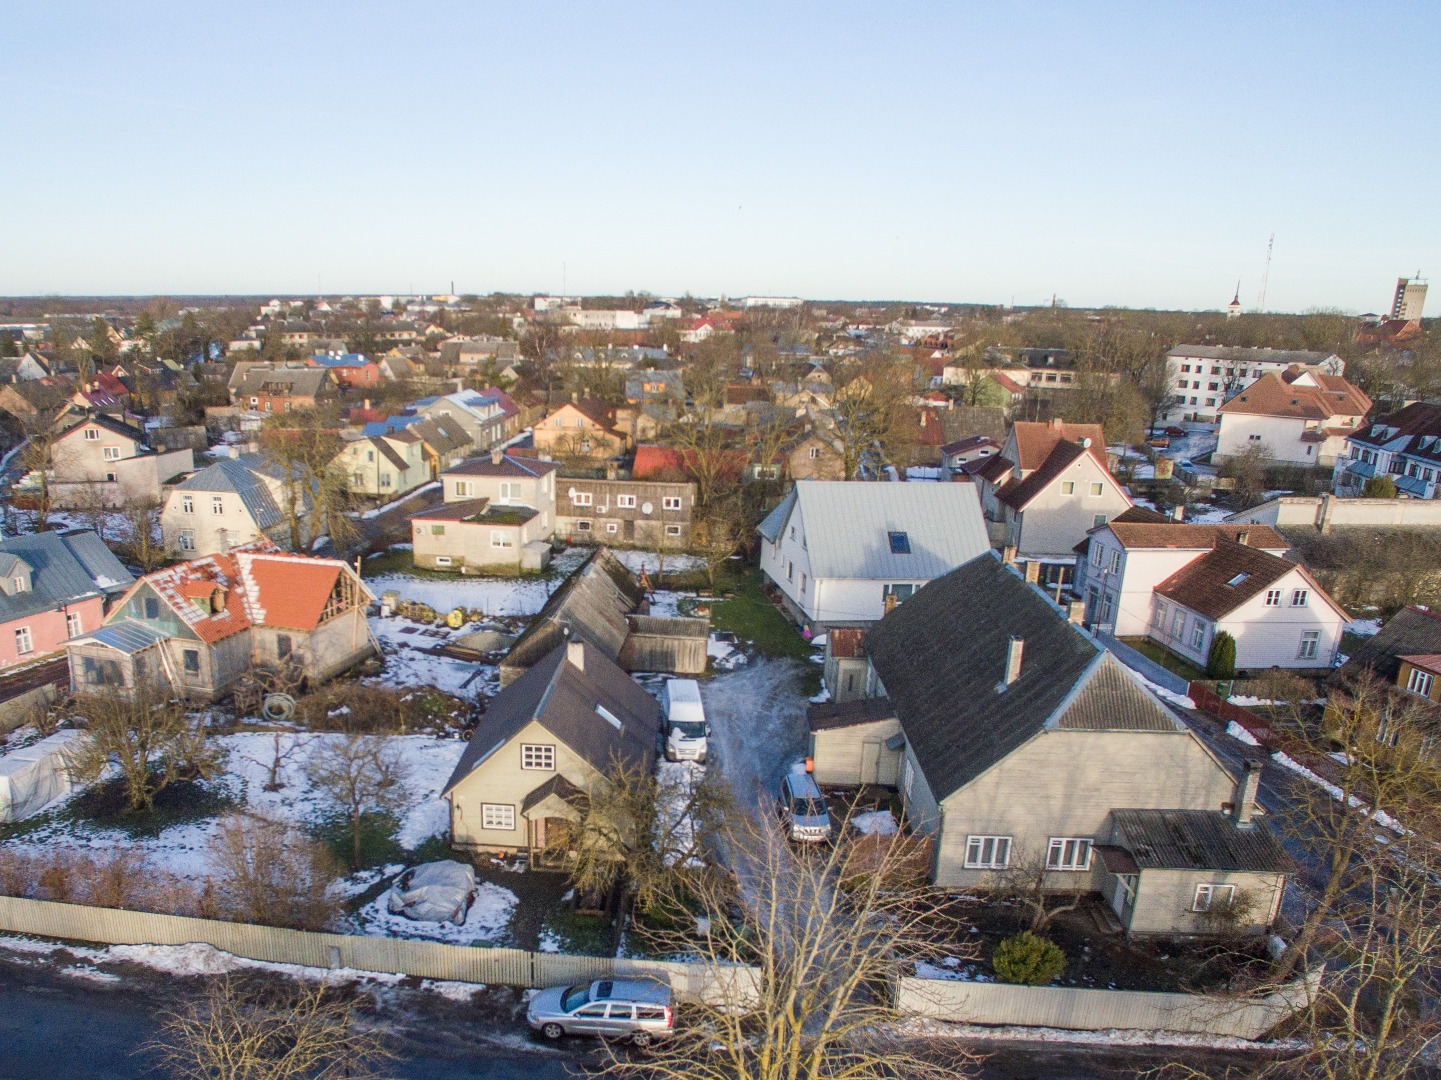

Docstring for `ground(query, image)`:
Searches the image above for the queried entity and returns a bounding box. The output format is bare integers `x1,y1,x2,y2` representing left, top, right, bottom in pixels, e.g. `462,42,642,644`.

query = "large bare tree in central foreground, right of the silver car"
605,813,977,1080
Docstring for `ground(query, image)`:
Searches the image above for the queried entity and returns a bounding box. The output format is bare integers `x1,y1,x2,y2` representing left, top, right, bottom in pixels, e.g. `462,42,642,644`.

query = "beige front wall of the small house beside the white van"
448,721,597,851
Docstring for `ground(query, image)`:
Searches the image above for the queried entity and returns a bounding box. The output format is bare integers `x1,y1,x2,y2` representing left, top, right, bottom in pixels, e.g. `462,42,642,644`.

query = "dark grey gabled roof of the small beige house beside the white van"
441,642,660,794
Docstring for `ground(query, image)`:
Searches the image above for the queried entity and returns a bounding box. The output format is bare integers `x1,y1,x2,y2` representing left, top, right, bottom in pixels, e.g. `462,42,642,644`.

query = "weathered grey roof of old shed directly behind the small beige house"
501,548,644,668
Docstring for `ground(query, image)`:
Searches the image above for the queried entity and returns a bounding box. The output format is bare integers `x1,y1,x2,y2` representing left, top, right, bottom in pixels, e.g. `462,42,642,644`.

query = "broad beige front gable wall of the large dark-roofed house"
928,731,1235,888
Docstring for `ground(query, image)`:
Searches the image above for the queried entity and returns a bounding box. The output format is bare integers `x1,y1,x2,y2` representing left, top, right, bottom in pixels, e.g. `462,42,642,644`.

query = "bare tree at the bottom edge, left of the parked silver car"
147,978,395,1080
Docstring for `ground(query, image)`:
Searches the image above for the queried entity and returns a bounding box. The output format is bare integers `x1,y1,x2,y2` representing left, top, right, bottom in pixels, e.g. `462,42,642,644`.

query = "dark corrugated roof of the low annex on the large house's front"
1111,810,1291,874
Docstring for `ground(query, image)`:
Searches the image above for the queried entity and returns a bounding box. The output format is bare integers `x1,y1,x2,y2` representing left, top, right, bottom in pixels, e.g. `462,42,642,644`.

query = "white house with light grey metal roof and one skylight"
758,480,990,629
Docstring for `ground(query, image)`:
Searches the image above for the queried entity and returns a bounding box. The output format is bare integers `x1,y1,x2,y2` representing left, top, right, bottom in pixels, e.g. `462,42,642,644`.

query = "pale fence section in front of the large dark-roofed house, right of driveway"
895,968,1321,1040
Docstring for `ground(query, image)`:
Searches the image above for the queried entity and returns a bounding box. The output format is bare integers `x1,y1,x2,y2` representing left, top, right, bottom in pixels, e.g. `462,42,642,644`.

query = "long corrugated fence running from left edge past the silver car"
0,897,758,998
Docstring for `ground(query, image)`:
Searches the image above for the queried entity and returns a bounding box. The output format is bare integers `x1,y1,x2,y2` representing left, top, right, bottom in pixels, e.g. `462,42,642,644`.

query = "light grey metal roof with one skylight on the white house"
761,480,990,581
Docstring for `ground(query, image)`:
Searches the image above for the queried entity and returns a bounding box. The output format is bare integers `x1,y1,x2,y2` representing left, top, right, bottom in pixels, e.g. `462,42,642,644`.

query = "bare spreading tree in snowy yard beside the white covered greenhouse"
71,679,222,813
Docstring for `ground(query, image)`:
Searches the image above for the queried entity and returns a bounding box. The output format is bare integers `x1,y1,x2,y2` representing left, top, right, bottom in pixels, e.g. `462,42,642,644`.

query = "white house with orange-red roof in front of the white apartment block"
1215,366,1370,467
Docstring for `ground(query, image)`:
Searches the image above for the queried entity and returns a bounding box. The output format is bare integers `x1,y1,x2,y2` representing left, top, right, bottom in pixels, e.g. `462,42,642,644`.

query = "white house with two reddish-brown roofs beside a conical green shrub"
1078,522,1349,670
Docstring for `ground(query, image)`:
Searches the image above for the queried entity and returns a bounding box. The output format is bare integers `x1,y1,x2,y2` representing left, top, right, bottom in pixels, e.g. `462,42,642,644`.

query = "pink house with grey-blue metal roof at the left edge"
0,529,135,668
